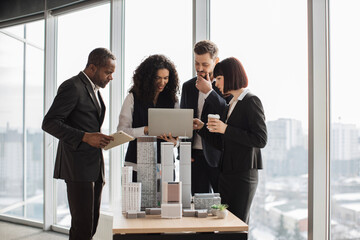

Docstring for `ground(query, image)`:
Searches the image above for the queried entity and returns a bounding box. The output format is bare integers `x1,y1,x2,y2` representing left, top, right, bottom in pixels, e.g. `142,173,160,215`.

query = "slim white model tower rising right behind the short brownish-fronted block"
161,142,174,182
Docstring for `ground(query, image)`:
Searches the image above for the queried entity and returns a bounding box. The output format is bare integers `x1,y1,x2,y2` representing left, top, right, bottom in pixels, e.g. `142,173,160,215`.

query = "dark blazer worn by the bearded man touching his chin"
180,77,226,167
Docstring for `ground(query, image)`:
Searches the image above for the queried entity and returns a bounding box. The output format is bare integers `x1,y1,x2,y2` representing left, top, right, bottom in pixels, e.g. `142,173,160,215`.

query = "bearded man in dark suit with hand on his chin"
180,40,225,194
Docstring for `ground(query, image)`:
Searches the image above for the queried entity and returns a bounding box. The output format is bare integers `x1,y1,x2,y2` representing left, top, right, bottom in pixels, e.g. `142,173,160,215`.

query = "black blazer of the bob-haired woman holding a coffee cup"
199,90,267,174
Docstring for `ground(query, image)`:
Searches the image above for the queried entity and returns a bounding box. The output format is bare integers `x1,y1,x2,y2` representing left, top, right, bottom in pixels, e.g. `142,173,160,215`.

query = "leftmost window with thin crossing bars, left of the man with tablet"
0,21,44,222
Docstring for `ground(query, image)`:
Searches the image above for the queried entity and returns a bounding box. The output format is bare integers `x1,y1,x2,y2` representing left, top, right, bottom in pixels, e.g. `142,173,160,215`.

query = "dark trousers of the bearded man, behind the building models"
191,149,220,195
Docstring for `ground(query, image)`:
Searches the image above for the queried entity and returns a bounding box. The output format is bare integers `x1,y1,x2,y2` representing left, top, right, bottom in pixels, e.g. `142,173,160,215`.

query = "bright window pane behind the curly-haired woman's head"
124,0,193,93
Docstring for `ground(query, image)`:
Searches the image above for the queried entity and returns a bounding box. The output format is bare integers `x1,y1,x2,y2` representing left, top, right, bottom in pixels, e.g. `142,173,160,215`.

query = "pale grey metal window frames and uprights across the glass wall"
0,0,330,240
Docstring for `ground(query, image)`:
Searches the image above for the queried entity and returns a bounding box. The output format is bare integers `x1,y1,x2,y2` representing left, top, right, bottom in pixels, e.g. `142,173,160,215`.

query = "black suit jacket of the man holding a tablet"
42,72,105,182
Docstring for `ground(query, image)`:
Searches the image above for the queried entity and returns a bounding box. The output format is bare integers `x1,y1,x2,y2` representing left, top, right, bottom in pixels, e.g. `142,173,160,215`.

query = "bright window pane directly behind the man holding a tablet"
56,4,110,227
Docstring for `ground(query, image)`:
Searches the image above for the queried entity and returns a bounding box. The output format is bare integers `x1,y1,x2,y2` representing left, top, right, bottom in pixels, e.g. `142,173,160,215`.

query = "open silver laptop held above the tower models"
148,108,194,138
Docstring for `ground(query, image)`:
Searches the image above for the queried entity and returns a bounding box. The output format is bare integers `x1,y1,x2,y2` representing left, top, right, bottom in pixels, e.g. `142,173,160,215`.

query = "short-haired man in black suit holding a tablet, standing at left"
42,48,116,240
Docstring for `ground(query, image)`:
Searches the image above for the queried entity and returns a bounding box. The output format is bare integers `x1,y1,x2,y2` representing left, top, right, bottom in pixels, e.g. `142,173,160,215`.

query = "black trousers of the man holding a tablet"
66,172,104,240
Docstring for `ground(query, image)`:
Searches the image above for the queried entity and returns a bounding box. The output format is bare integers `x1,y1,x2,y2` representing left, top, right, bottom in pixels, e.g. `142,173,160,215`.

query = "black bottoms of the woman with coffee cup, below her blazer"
219,169,258,224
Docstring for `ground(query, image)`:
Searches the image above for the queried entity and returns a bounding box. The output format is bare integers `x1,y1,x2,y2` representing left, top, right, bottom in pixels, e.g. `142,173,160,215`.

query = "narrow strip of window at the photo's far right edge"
329,0,360,240
